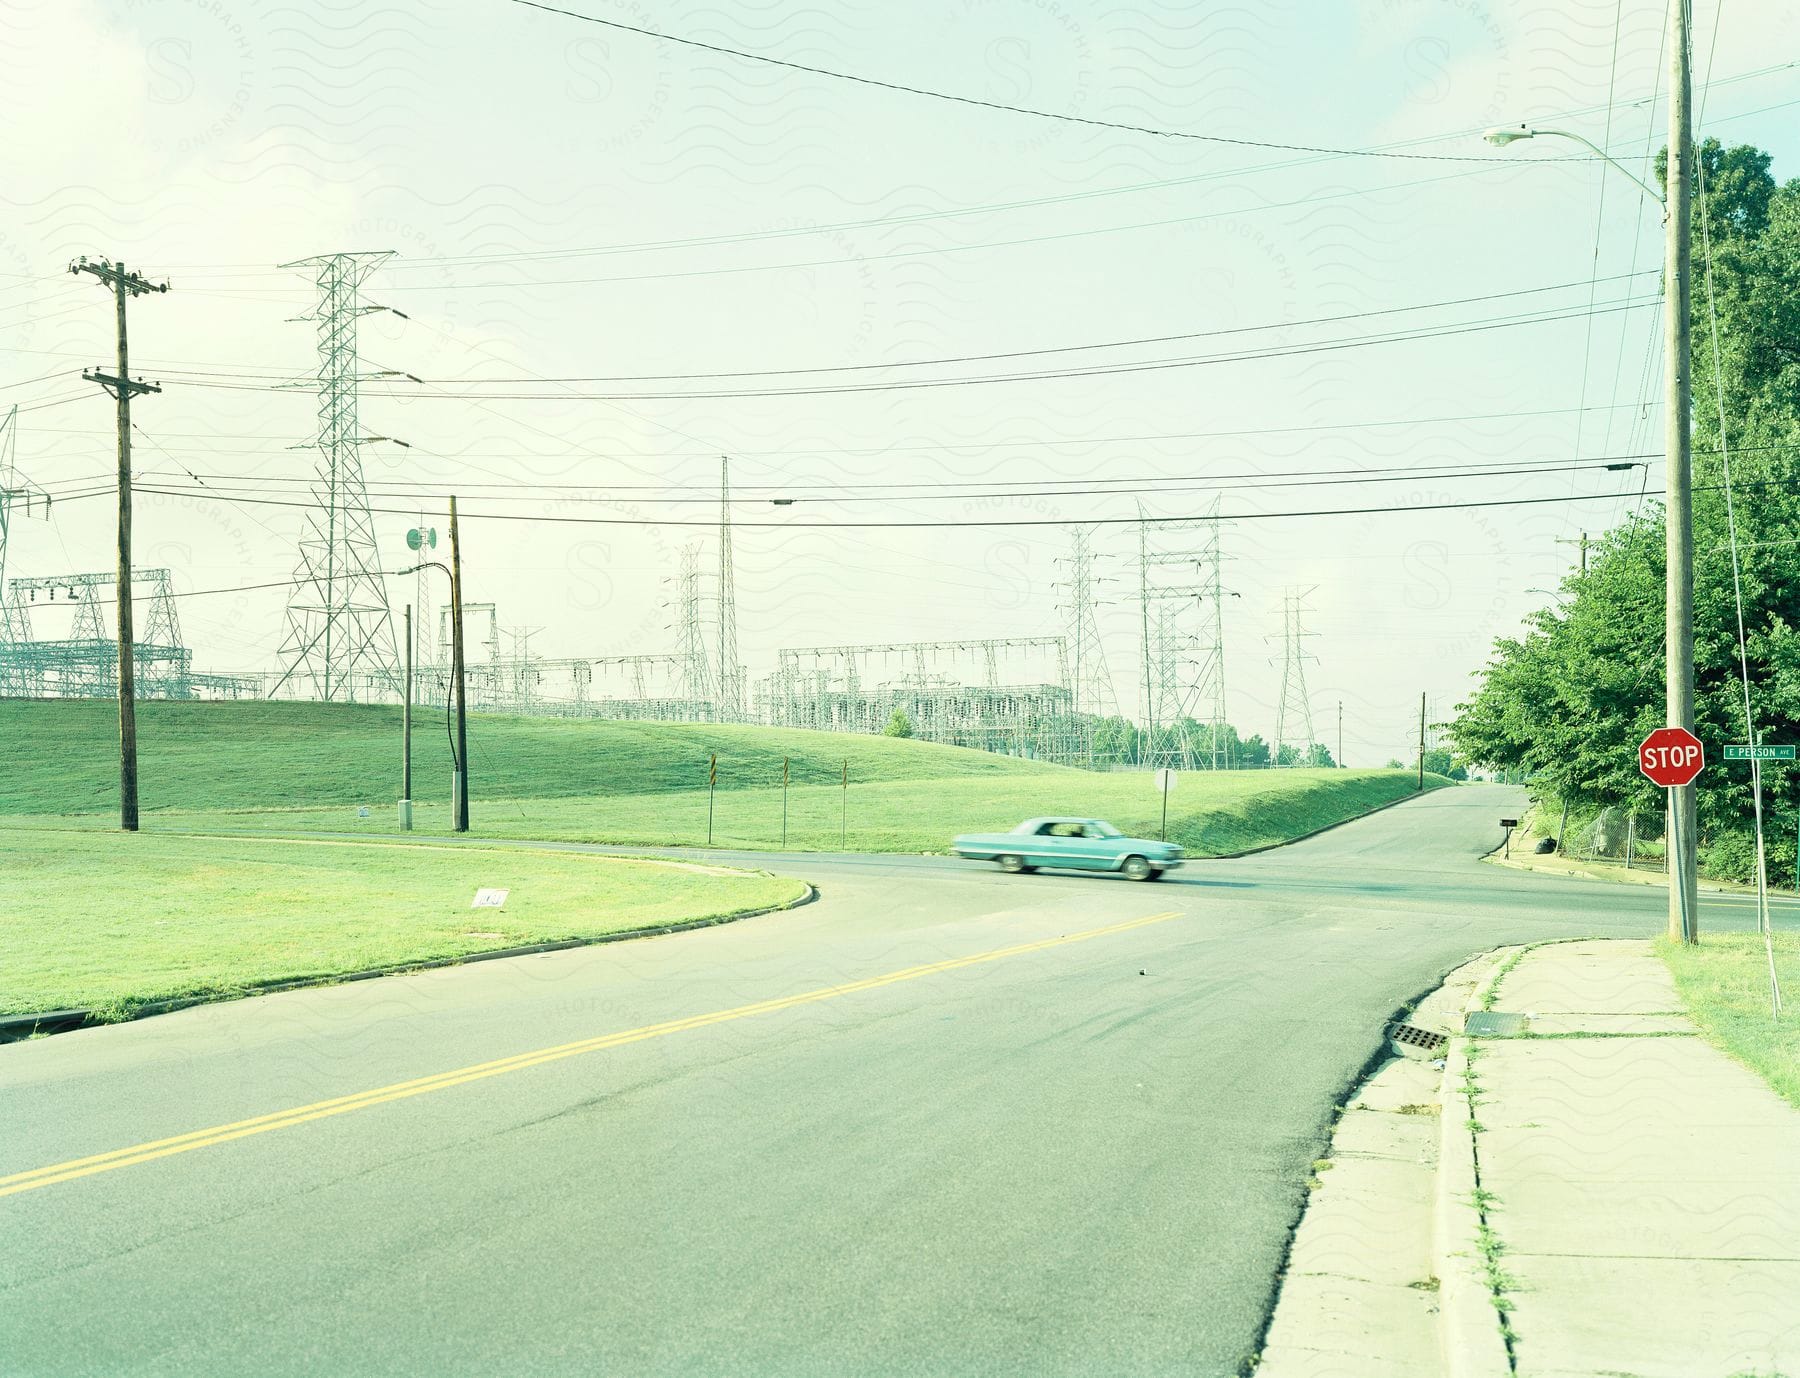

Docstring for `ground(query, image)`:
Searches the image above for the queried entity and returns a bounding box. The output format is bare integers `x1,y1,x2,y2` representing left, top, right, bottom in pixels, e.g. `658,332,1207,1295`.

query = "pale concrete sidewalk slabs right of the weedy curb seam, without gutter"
1469,941,1800,1378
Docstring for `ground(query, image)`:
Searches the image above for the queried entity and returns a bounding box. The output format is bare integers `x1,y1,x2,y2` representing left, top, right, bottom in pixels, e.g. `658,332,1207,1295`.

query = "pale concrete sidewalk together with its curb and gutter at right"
1258,941,1800,1378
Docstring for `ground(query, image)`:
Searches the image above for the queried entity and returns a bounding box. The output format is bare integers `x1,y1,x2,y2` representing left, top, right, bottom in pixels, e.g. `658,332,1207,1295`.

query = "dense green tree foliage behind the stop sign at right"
1451,140,1800,874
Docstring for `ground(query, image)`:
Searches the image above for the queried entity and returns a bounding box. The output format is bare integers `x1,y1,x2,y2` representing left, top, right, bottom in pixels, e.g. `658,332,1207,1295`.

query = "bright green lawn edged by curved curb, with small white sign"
0,829,805,1018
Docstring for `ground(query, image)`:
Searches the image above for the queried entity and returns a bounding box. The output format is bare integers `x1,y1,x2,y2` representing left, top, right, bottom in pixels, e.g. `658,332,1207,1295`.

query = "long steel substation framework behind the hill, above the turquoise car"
754,637,1087,763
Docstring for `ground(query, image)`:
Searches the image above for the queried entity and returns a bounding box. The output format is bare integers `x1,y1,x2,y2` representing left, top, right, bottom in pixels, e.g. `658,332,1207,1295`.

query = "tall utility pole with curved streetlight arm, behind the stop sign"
1483,0,1699,943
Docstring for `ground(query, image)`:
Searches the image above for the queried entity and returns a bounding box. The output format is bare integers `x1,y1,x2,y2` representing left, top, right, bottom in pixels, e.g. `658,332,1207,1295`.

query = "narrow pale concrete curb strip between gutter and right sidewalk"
1431,948,1516,1378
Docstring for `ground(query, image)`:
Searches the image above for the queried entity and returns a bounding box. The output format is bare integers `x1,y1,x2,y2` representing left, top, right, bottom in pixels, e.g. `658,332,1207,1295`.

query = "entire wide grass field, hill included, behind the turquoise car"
0,700,1444,856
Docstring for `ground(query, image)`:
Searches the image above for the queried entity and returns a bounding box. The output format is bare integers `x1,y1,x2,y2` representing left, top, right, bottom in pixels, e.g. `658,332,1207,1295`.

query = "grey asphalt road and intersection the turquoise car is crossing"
0,786,1785,1374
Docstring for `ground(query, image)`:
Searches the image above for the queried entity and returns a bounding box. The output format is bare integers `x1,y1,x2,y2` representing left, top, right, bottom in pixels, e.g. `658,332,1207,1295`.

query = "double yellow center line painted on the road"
0,910,1181,1196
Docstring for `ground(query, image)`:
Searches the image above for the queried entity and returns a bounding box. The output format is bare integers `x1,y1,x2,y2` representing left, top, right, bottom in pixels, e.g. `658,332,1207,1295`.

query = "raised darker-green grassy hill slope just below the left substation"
0,700,1058,813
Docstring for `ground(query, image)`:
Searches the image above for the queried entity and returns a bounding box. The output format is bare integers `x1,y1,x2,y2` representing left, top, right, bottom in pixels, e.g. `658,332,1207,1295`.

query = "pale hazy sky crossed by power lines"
0,0,1800,765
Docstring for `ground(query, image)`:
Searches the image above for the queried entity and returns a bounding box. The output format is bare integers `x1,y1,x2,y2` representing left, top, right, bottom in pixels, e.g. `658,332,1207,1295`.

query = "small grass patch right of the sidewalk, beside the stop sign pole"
1658,934,1800,1106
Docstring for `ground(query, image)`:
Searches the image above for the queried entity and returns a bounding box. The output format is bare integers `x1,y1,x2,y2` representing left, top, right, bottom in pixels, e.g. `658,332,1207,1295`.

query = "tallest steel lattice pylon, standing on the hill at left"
270,250,400,702
